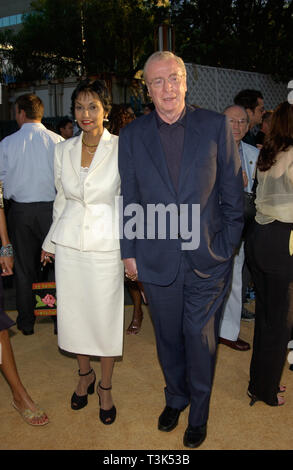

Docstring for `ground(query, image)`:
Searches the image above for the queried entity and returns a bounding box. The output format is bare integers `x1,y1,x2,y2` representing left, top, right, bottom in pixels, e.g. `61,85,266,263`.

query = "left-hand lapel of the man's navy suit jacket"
143,113,176,196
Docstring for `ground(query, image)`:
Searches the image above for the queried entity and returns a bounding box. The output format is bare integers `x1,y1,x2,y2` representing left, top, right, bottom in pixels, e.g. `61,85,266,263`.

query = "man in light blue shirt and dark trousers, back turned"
0,93,63,335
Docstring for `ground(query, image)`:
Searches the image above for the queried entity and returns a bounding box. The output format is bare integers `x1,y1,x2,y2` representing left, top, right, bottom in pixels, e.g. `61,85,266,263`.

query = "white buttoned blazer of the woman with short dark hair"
43,129,120,253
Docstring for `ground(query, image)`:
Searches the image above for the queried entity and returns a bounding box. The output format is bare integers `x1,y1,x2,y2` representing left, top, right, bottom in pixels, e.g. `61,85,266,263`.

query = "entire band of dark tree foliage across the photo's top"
0,0,293,81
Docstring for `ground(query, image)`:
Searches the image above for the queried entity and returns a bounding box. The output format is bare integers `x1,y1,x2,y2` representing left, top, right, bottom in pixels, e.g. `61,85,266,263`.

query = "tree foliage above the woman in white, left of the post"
0,0,164,80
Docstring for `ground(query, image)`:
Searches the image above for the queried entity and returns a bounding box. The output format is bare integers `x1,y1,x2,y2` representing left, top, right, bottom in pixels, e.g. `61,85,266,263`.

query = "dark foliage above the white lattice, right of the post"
172,0,293,81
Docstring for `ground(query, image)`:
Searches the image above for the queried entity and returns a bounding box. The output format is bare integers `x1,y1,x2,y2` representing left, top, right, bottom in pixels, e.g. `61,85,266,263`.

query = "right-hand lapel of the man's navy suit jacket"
178,111,200,193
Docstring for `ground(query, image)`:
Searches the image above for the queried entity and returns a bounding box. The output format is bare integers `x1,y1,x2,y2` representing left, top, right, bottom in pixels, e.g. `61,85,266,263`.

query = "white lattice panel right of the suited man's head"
185,64,289,112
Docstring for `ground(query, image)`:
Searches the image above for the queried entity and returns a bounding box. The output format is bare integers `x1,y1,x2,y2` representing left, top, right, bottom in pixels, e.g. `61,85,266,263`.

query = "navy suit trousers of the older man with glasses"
144,252,231,426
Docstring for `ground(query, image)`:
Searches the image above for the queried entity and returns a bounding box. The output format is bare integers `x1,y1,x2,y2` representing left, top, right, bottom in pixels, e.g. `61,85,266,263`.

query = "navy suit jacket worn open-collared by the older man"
118,109,243,285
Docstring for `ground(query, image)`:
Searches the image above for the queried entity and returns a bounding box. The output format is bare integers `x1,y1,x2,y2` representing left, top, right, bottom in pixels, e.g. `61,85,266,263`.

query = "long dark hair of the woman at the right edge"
257,101,293,171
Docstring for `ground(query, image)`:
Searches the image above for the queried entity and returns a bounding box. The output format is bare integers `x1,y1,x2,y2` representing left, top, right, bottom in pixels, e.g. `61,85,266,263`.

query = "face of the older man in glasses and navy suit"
146,58,187,124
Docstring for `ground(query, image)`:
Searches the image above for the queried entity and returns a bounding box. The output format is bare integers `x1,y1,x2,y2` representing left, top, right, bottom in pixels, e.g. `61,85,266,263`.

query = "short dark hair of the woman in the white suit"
71,78,112,117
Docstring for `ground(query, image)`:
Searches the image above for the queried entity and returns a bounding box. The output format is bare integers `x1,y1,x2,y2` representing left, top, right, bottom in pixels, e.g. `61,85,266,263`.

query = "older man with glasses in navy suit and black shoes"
119,51,243,447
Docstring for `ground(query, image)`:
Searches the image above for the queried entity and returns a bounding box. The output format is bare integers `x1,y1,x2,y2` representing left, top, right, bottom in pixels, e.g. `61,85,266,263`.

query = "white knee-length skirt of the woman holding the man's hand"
55,245,124,357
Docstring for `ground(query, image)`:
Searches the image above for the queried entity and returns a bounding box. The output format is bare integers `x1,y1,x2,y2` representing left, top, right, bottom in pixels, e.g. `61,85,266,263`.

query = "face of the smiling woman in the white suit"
74,93,105,133
